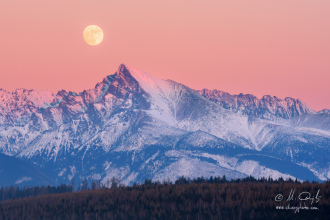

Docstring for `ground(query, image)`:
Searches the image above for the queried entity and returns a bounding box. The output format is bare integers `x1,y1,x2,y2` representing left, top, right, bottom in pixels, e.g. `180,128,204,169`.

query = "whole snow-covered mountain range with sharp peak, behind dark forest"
0,64,330,185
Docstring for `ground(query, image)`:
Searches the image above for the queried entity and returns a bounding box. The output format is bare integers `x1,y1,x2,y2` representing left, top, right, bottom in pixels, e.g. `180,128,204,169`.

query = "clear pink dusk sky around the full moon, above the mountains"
0,0,330,110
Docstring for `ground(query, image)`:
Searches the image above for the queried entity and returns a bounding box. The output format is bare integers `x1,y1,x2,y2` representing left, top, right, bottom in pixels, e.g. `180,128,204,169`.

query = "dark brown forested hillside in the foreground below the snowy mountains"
0,177,330,220
